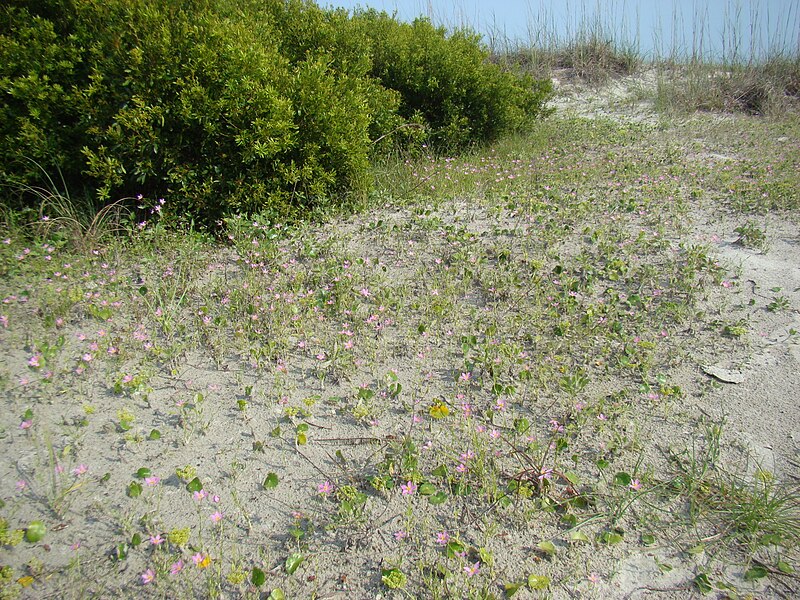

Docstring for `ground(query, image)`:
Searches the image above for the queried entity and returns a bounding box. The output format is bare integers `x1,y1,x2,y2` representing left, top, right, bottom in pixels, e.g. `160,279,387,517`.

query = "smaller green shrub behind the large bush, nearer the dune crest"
354,10,551,148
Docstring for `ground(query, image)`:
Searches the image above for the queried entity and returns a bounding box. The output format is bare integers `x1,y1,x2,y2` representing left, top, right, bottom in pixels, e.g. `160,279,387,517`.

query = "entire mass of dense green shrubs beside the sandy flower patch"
0,0,549,225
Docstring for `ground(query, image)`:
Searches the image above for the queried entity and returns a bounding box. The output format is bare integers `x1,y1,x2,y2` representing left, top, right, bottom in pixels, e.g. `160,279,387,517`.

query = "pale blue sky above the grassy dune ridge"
324,0,800,59
